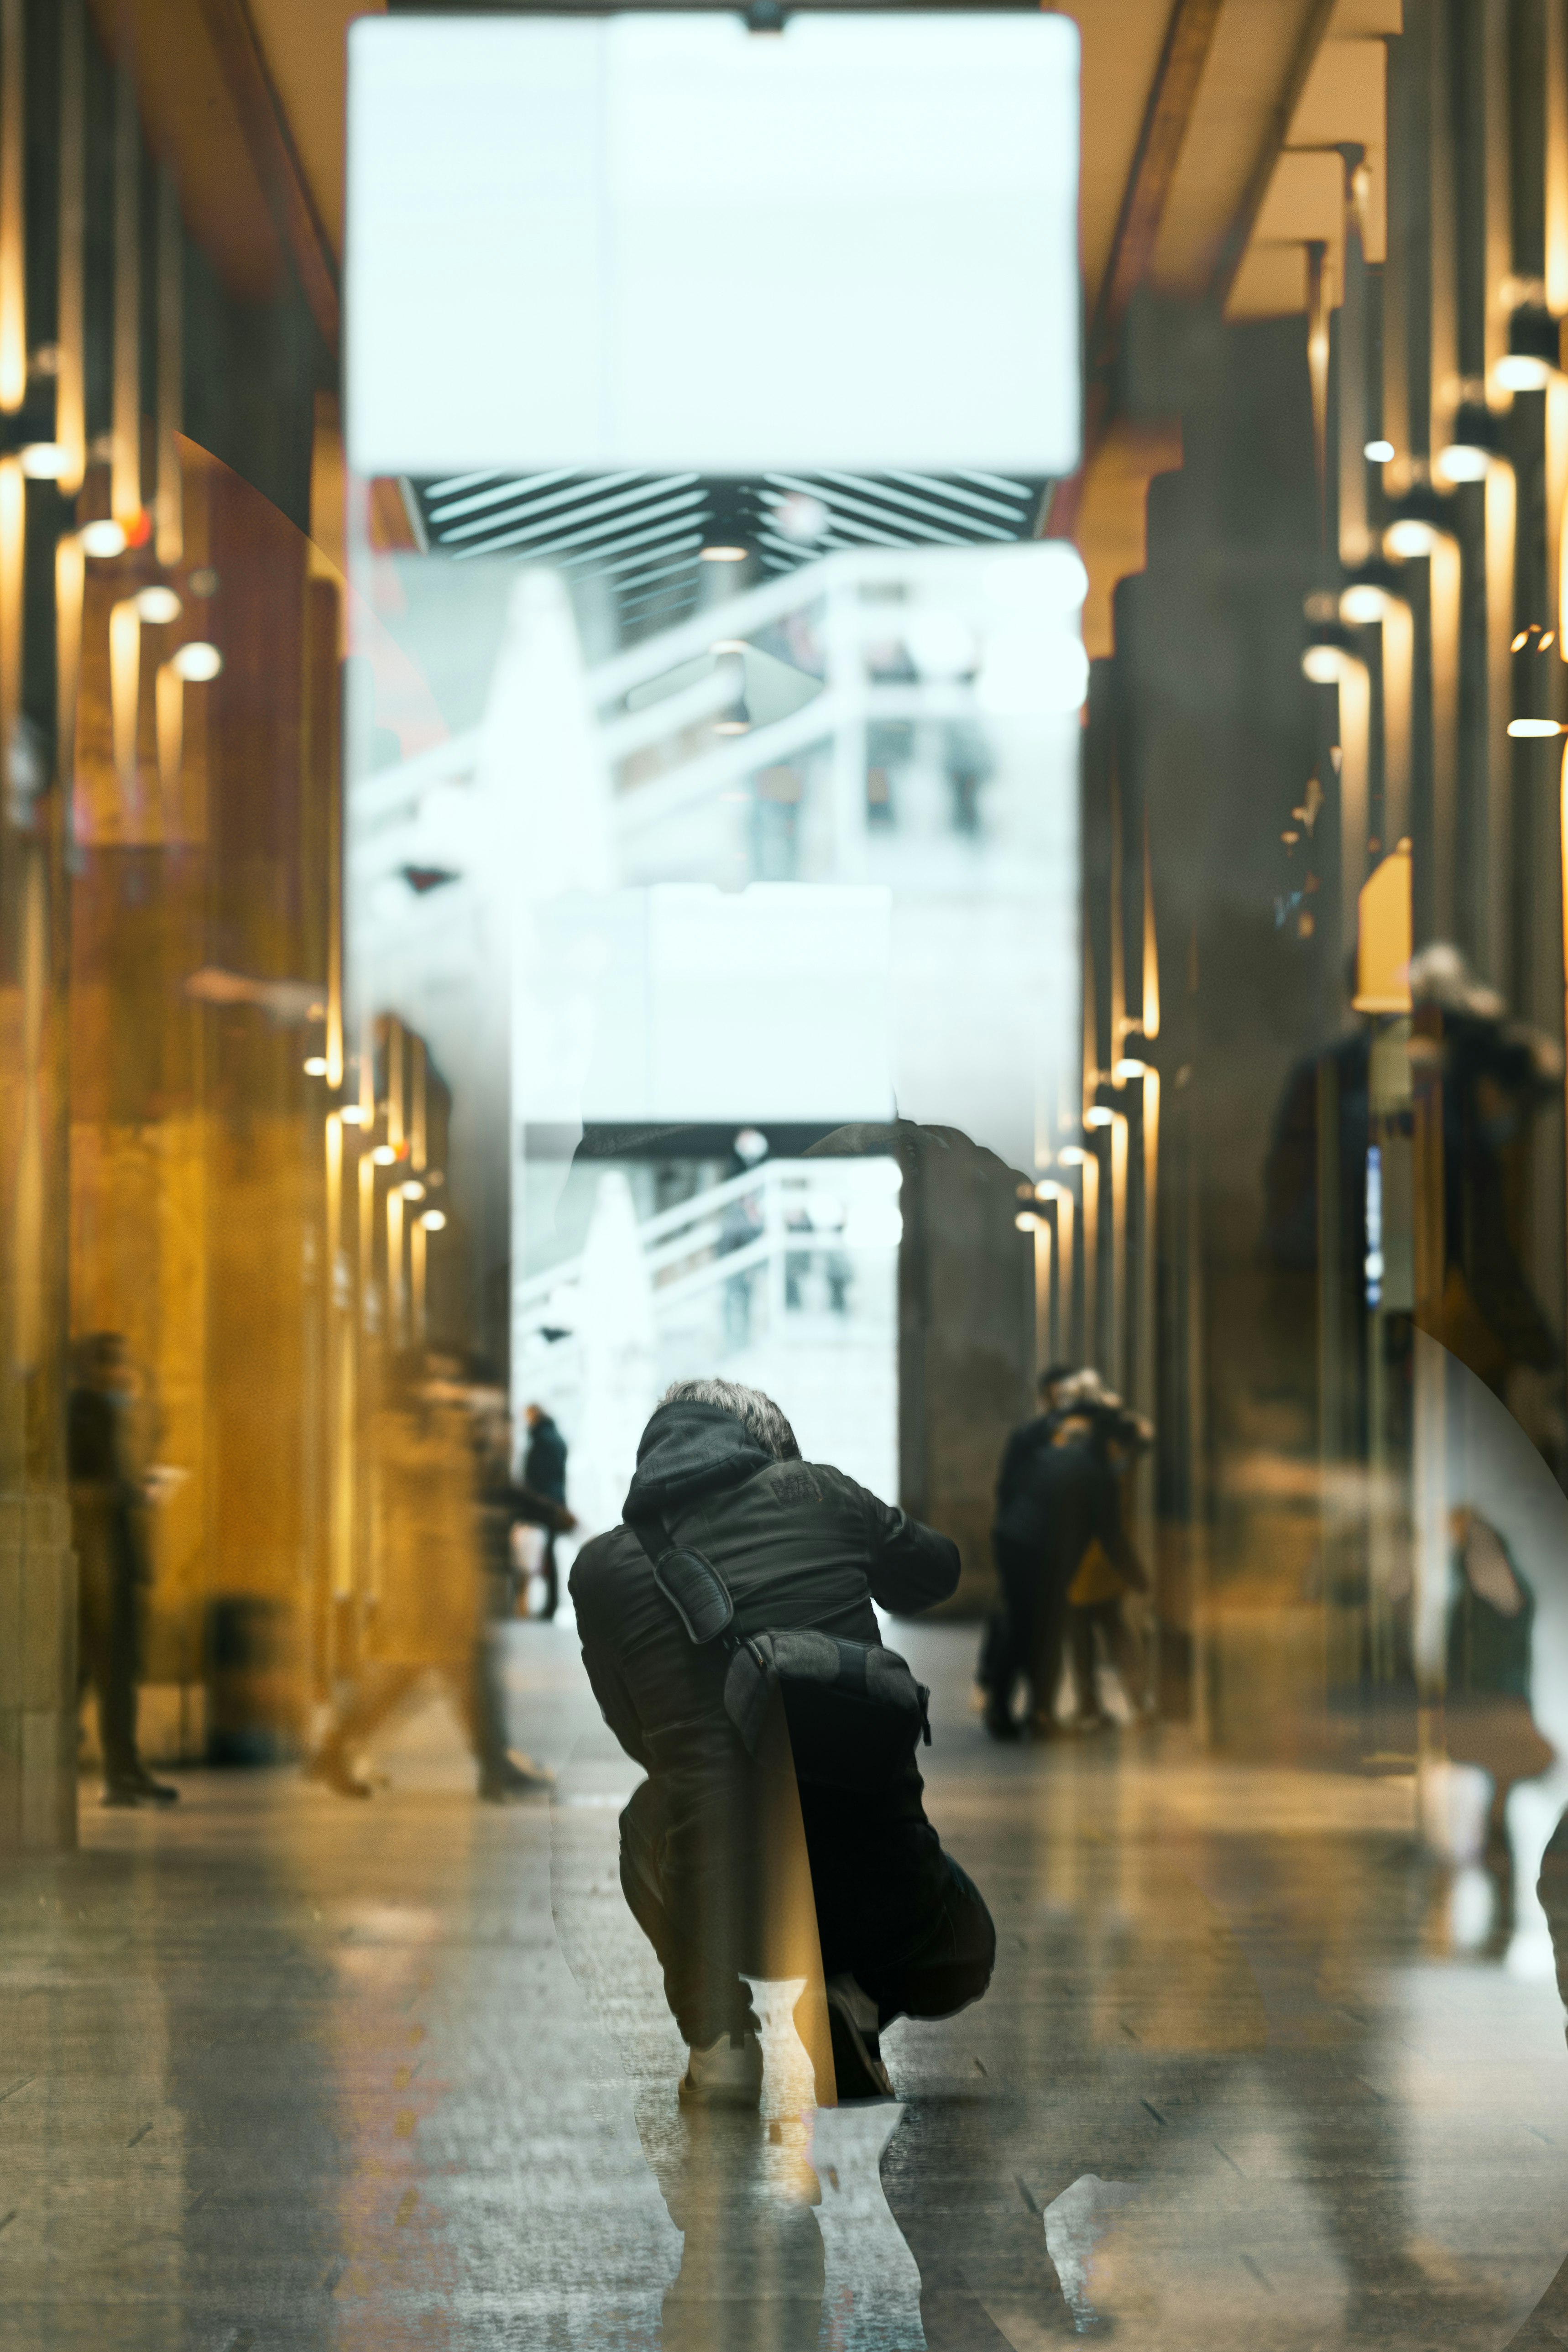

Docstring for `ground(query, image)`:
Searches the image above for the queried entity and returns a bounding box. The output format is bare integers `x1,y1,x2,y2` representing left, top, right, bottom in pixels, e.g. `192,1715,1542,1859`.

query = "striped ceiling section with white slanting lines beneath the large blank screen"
416,473,1046,640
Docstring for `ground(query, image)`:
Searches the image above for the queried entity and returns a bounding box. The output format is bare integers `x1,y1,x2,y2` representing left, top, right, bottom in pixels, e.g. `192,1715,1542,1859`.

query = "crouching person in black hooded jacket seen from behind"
571,1380,997,2105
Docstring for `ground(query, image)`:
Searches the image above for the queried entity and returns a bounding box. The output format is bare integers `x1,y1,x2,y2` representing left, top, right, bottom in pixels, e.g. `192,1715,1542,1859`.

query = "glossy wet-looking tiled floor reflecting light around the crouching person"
0,1628,1568,2352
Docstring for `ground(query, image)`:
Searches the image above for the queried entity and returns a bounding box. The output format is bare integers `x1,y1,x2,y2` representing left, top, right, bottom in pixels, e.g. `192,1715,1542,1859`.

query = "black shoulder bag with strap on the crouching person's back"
627,1519,931,1790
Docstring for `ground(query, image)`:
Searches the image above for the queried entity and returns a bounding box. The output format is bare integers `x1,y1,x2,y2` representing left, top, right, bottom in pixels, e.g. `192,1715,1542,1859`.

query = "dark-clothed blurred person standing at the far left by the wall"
66,1331,179,1806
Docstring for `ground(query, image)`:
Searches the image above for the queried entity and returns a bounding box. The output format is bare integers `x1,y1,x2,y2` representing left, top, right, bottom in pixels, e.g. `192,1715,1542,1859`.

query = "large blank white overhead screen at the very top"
348,12,1079,475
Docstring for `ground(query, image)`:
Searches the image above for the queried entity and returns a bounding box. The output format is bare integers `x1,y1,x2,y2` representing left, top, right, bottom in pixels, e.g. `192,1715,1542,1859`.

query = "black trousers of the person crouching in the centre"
621,1781,997,2049
